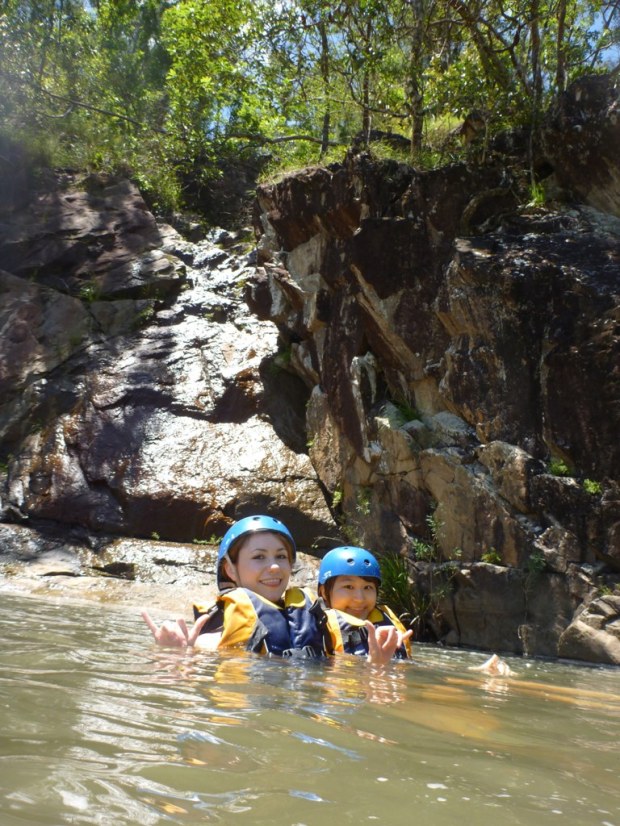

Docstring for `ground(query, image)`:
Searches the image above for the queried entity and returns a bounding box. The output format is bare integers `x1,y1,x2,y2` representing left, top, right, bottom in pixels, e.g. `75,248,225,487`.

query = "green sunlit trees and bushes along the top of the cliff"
0,0,620,210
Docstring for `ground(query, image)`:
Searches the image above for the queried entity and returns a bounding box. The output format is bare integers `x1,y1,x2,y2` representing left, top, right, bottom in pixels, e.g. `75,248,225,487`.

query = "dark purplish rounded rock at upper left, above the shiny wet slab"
0,176,184,300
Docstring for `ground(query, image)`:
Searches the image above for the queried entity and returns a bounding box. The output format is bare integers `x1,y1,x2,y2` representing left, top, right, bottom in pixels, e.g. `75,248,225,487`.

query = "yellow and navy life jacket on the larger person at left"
194,588,333,658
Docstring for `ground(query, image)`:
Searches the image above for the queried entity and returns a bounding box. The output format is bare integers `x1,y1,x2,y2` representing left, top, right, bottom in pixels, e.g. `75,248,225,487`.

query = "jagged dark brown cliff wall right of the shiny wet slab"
247,72,620,663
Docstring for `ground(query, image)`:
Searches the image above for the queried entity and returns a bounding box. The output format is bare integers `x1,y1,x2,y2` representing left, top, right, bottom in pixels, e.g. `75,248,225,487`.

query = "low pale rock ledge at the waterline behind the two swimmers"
0,523,318,612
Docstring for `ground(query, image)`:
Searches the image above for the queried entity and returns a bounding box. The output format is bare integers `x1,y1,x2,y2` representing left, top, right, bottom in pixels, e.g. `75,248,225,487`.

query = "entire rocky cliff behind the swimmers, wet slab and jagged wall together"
0,78,620,664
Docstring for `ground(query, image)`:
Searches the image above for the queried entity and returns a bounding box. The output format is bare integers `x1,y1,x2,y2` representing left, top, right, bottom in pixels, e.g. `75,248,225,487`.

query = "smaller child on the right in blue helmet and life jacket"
319,546,412,659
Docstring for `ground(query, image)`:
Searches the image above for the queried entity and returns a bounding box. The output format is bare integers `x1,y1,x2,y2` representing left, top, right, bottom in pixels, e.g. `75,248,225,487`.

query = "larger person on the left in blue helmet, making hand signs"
142,516,404,665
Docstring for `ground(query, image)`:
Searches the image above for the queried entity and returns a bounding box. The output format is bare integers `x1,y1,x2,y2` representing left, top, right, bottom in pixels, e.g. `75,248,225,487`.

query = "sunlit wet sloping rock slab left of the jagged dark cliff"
0,170,334,546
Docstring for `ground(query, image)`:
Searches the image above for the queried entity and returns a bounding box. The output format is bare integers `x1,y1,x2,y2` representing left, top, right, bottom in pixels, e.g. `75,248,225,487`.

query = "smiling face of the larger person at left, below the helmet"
225,531,291,602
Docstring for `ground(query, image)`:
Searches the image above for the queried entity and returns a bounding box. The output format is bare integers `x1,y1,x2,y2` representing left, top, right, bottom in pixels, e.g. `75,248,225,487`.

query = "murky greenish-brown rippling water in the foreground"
0,595,620,826
